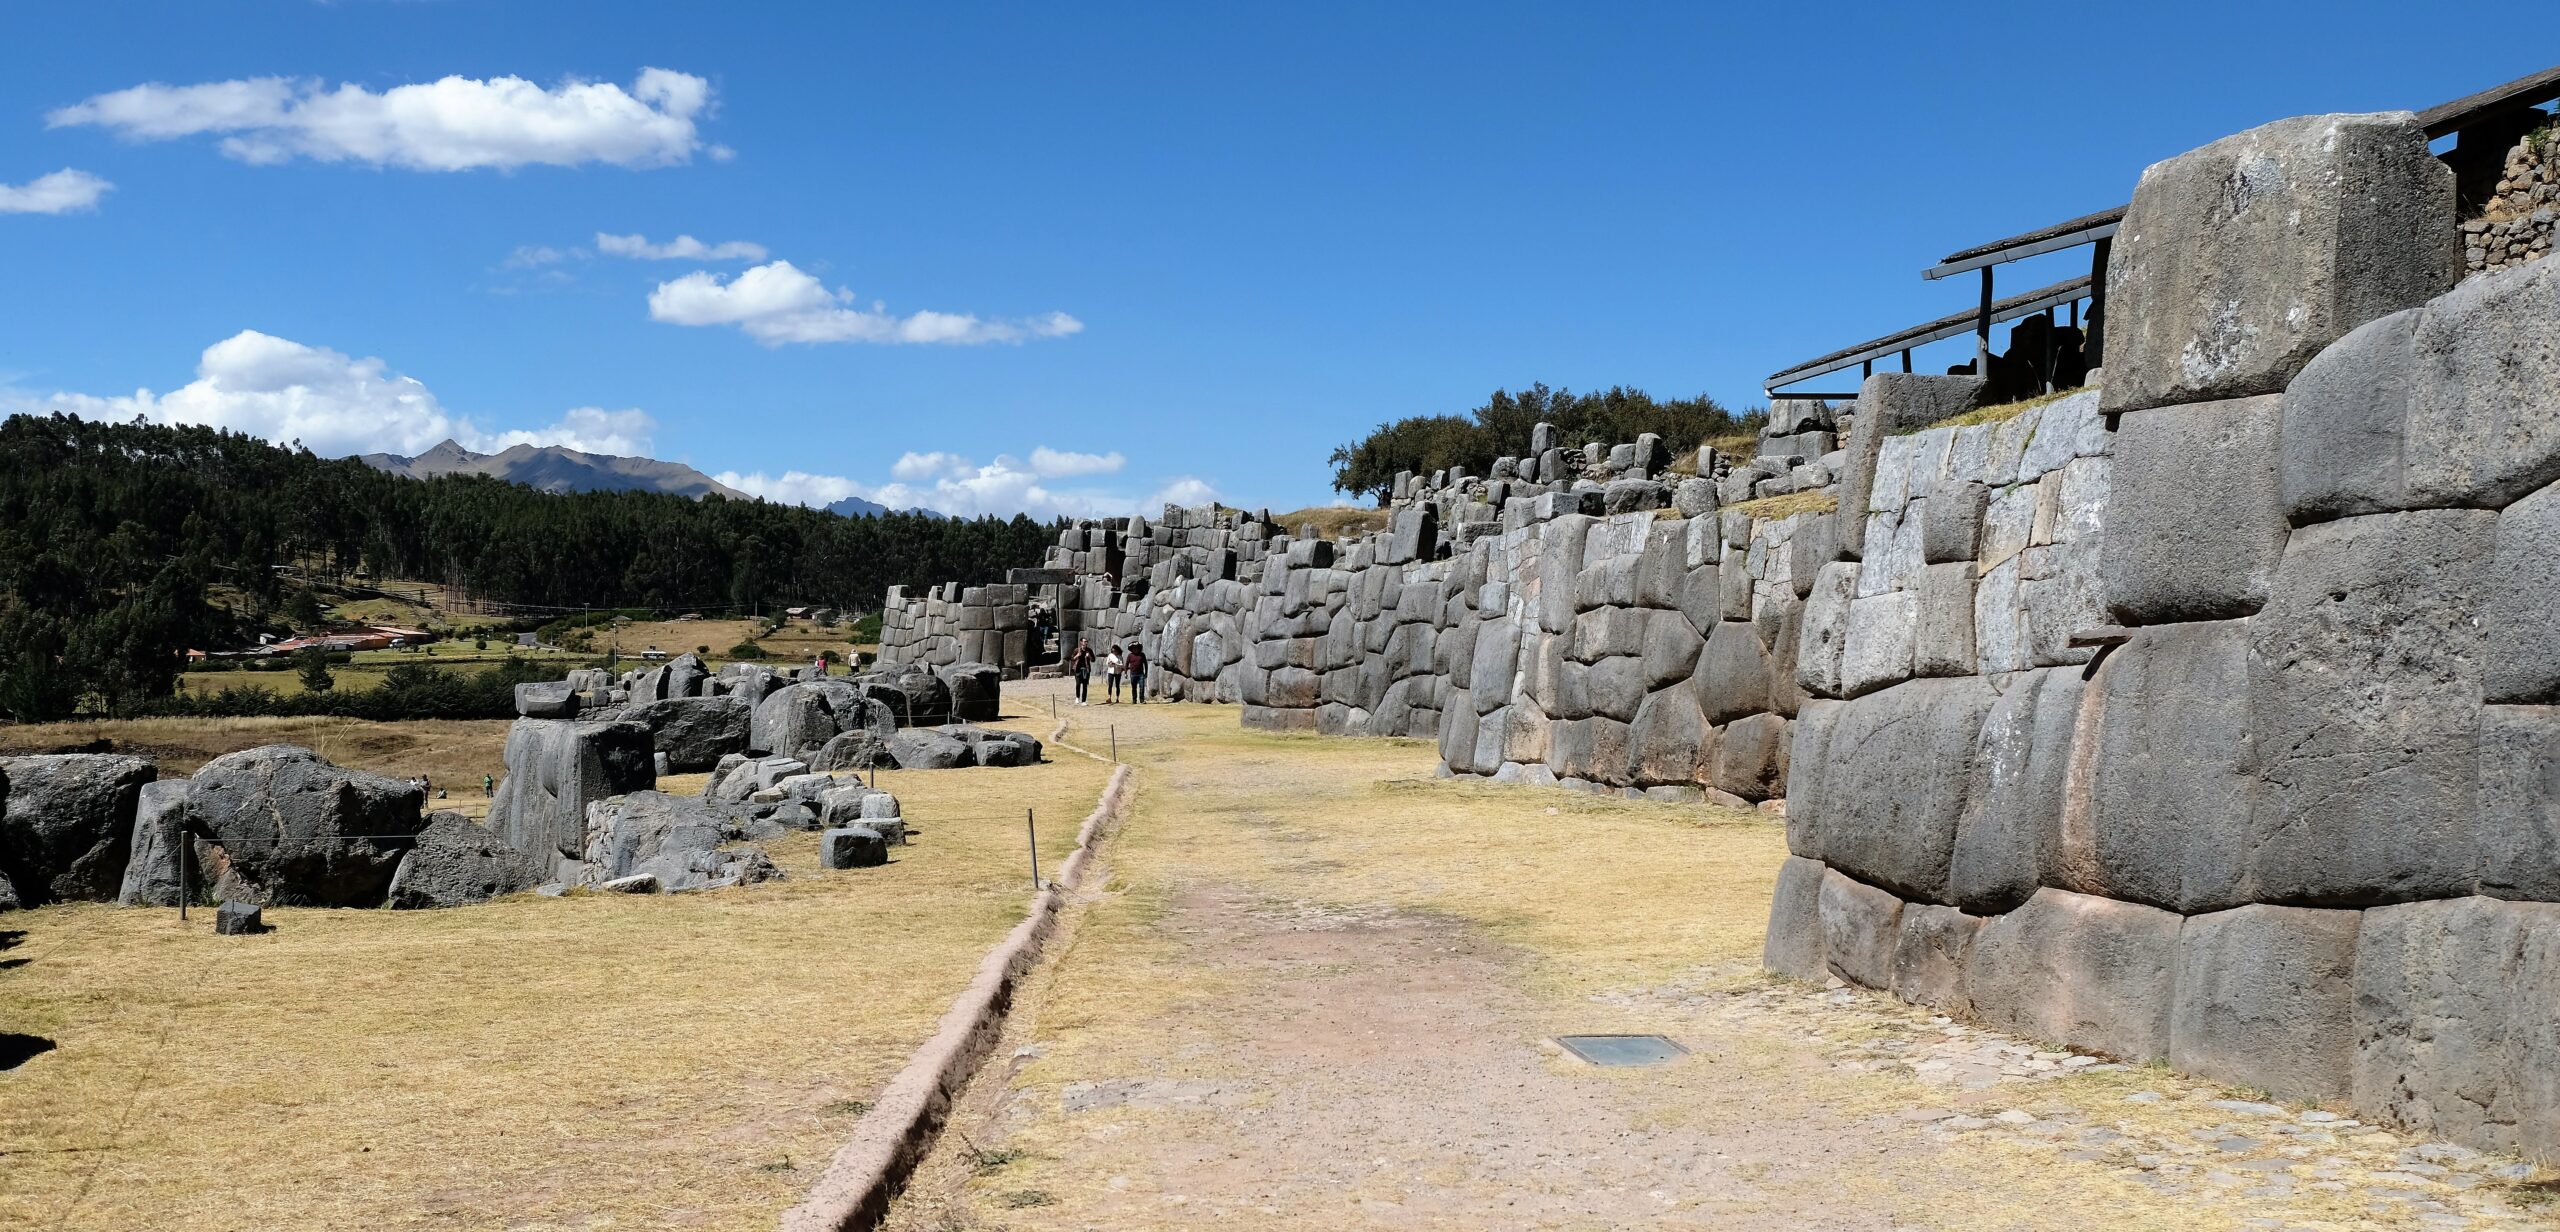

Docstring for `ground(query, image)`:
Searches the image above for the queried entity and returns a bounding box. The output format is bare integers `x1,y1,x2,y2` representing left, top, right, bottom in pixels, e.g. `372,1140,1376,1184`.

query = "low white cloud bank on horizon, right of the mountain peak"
714,446,1219,520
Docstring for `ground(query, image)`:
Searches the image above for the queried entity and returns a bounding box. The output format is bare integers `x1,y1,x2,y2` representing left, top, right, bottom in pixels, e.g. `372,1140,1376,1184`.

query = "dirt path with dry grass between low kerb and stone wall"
891,681,2560,1232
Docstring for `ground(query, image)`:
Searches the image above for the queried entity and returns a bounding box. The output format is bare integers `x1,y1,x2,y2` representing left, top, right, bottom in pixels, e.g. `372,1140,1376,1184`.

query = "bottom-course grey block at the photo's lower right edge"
2353,899,2560,1158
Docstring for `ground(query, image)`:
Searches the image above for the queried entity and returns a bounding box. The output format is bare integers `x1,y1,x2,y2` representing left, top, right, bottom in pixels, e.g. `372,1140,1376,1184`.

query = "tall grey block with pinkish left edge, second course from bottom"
2078,620,2260,912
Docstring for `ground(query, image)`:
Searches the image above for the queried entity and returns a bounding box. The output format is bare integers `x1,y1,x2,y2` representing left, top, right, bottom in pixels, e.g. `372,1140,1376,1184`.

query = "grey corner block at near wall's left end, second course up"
1822,676,1997,904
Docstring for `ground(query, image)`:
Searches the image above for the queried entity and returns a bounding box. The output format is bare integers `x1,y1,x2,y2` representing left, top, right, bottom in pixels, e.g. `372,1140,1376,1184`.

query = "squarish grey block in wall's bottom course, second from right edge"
2168,904,2363,1101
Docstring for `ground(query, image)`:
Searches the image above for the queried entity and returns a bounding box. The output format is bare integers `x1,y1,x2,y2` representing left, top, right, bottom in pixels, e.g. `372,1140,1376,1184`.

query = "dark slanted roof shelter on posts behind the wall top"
1761,67,2560,397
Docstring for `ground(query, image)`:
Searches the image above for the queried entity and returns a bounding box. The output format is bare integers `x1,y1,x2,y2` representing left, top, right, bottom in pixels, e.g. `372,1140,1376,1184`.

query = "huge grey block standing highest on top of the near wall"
2099,113,2460,415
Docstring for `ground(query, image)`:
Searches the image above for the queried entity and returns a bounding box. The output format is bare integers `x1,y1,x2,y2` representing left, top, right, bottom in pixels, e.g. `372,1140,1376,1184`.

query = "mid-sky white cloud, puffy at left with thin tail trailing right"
648,261,1085,346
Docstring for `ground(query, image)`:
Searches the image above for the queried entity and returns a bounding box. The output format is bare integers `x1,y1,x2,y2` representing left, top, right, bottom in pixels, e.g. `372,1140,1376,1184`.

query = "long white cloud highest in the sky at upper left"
46,69,712,172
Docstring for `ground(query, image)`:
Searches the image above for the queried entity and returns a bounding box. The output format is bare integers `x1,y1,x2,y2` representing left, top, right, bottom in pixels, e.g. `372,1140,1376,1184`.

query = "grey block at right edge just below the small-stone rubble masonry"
2404,261,2560,507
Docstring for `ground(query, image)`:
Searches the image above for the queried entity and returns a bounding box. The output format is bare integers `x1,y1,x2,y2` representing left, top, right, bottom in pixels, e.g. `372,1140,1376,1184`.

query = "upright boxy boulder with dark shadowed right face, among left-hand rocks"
489,720,658,861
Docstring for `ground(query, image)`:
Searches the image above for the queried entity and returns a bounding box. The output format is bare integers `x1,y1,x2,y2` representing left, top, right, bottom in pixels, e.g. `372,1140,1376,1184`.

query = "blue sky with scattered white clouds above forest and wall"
0,0,2529,515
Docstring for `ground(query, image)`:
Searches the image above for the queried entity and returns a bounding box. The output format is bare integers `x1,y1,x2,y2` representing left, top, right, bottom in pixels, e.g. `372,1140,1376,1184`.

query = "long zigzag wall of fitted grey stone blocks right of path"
880,113,2560,1158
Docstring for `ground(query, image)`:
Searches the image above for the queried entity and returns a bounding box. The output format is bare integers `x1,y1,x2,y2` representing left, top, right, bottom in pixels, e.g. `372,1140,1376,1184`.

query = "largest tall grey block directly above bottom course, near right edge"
2248,510,2499,904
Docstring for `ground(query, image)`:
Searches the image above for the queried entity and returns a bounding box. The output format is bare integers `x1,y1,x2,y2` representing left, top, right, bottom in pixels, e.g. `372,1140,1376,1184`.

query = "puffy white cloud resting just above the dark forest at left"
36,330,658,456
